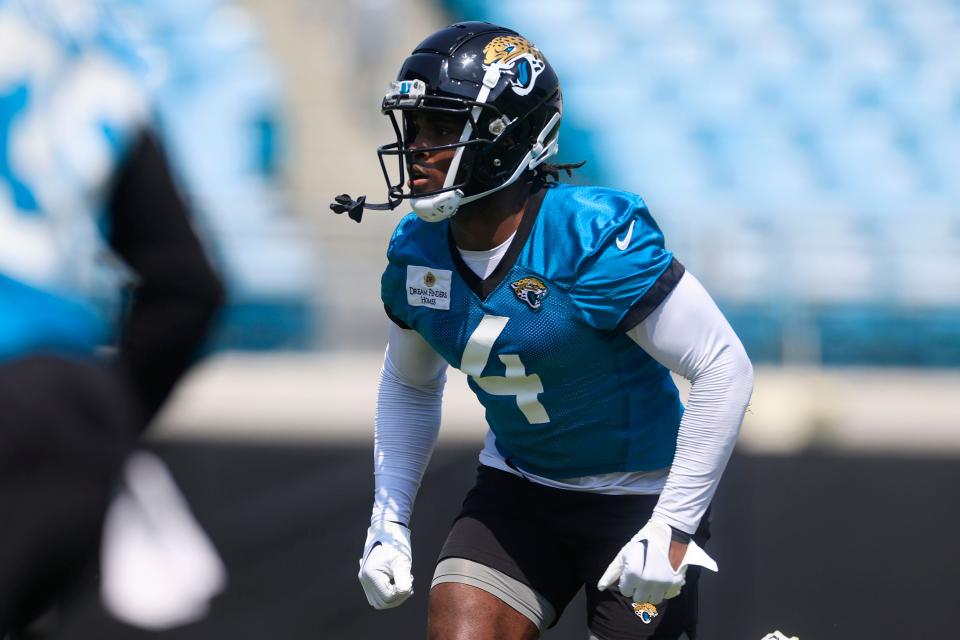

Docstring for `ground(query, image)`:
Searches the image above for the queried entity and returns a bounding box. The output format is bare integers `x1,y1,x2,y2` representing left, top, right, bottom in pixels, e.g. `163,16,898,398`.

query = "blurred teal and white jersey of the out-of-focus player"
0,0,149,363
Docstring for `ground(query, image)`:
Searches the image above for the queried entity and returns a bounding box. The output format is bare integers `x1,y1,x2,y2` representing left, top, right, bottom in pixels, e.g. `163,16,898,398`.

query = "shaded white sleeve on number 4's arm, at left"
370,323,447,526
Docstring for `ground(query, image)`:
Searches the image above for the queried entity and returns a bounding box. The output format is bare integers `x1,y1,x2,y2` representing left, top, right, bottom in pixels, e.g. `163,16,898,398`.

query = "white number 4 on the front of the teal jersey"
460,315,550,424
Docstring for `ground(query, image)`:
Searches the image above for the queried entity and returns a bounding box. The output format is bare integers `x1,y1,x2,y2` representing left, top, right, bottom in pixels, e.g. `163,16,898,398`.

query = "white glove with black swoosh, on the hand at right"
597,520,717,604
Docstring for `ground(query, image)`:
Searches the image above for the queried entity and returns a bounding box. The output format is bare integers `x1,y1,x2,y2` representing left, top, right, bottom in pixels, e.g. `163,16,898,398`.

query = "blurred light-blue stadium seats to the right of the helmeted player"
445,0,960,367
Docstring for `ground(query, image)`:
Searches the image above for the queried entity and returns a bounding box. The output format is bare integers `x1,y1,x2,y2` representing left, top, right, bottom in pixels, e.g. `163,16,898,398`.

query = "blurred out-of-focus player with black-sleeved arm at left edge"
0,0,221,637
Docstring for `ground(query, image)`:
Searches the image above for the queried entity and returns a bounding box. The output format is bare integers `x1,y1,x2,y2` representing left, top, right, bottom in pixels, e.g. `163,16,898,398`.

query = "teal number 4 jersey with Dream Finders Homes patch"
381,185,683,479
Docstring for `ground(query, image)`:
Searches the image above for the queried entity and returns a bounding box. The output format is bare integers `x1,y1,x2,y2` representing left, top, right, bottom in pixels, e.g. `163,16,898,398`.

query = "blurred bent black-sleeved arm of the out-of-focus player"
110,132,223,428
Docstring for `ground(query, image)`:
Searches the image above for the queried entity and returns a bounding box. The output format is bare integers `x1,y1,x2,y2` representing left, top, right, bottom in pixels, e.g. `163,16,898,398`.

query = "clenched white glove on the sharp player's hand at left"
357,522,413,609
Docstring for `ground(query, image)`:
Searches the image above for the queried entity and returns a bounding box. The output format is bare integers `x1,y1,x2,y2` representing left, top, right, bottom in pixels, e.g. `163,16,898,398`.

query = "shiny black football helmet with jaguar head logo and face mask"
330,22,563,222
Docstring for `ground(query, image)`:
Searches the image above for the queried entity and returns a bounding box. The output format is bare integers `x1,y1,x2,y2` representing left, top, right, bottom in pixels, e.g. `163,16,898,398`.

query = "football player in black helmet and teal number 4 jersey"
332,22,753,640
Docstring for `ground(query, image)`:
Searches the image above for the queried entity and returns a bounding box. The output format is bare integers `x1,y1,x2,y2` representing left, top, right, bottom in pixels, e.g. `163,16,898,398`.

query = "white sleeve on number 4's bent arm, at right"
628,272,753,533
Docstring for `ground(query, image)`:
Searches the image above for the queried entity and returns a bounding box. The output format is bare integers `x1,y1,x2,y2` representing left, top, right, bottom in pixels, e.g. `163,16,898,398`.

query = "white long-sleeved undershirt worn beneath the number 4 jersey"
371,240,753,533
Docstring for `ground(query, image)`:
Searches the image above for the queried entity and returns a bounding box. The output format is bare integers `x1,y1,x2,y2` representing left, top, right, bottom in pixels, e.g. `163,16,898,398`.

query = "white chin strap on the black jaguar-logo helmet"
410,64,560,222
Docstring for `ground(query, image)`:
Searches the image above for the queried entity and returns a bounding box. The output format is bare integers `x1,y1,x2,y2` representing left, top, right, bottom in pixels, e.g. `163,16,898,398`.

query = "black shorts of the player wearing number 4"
439,465,709,640
